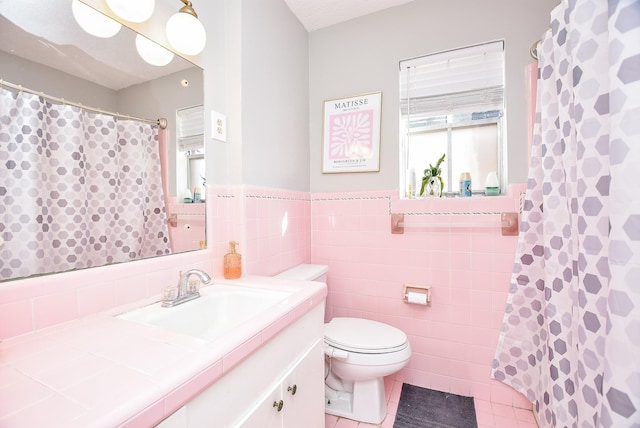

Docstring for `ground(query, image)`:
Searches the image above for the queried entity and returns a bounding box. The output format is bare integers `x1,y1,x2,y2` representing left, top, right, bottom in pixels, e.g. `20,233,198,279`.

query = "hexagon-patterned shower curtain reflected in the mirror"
0,88,170,280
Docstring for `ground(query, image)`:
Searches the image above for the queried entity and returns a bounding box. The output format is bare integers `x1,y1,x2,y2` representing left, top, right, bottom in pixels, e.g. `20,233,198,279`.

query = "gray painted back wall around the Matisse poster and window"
309,0,558,192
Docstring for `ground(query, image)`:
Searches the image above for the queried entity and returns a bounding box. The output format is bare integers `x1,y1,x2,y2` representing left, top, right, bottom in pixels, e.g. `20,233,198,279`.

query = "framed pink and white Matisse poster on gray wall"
322,92,382,174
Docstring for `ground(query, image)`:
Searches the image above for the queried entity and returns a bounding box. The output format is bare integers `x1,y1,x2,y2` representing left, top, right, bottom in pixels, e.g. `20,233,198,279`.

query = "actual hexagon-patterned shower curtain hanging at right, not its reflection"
492,0,640,427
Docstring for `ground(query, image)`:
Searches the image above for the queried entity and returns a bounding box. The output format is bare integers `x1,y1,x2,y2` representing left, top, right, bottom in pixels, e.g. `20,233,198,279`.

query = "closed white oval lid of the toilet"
324,318,407,354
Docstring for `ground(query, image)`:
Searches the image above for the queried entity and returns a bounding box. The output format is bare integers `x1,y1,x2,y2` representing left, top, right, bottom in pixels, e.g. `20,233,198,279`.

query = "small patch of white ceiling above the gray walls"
284,0,413,32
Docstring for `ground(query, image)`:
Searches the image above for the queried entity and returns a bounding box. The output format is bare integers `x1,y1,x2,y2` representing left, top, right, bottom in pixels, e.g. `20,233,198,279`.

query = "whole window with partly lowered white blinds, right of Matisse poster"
400,41,505,197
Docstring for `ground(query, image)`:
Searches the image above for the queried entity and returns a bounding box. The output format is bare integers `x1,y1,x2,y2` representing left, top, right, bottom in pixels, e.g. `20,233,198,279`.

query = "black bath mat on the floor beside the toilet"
393,383,478,428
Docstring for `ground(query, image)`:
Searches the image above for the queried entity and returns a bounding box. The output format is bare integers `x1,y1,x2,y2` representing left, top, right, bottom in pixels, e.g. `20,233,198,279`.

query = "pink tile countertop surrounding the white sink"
0,276,327,428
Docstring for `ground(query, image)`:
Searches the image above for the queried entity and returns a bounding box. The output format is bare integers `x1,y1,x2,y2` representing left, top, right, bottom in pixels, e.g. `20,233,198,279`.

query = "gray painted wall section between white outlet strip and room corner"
241,0,309,191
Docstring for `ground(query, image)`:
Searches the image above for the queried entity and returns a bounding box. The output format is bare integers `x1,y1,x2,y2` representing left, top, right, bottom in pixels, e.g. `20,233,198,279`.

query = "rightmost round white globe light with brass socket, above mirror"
167,0,207,55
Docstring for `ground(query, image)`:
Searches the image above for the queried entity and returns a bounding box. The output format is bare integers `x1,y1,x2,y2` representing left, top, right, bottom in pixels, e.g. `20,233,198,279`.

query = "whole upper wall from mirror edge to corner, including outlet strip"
198,0,309,191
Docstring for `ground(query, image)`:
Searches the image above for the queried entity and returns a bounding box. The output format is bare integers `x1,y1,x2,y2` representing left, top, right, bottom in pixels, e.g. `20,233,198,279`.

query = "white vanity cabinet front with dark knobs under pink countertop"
158,303,325,428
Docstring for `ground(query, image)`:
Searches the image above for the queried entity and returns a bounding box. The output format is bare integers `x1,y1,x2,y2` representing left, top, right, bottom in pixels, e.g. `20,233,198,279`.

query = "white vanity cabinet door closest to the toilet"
282,340,325,428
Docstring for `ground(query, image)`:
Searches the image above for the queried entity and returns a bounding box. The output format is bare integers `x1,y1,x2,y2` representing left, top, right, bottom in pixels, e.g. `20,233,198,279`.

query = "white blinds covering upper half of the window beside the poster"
400,41,504,121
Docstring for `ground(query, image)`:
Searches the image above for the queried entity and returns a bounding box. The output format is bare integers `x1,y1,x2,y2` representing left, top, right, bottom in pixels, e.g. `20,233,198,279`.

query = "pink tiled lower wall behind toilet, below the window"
311,188,519,402
